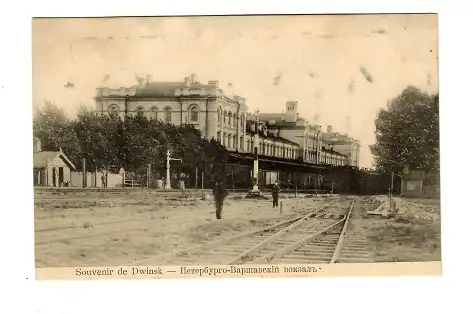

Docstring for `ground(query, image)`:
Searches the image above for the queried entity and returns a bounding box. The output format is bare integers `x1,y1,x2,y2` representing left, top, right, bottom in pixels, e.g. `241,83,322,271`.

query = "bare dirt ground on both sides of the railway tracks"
35,192,441,267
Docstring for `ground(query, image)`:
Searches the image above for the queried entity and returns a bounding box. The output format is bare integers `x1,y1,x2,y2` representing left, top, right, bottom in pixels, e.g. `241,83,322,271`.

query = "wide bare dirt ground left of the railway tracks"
35,193,336,267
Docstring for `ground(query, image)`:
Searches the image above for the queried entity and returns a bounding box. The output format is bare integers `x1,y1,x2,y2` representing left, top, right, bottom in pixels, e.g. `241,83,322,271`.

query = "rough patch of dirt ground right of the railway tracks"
364,199,441,262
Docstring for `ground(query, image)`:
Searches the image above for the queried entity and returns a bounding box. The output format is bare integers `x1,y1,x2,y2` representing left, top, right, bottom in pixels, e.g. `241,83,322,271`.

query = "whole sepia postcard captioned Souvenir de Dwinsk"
31,14,441,280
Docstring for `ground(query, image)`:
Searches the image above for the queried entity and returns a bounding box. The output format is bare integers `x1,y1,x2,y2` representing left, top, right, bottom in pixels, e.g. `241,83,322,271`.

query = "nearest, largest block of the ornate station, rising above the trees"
95,74,248,150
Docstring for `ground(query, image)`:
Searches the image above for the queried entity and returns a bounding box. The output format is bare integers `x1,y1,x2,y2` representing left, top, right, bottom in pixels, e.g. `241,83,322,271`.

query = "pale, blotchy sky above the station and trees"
33,15,438,167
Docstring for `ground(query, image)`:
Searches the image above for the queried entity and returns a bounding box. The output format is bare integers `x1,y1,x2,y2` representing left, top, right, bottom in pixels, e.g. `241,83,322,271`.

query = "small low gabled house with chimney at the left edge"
33,139,75,187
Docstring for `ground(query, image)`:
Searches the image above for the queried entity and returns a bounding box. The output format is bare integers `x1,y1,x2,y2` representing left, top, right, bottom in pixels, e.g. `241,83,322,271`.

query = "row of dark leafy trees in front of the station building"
33,103,228,181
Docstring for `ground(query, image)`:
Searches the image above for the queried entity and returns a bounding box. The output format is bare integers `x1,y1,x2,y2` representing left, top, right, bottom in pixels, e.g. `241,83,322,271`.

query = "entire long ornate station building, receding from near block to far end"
95,74,359,166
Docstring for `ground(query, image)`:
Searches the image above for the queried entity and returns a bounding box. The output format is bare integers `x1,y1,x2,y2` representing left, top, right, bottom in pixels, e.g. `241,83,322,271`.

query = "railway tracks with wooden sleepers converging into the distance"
135,200,369,265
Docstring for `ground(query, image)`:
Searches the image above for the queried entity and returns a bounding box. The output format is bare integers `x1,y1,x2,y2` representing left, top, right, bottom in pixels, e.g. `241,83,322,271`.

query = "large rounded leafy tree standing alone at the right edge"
370,86,440,172
